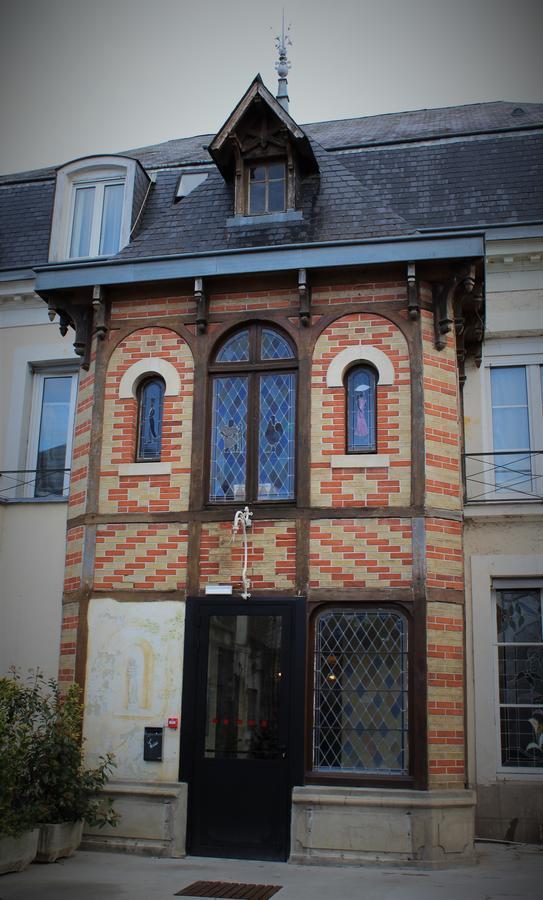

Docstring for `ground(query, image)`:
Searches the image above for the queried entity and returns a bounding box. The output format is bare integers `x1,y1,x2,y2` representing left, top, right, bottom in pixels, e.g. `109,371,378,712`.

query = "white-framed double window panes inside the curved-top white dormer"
69,179,124,258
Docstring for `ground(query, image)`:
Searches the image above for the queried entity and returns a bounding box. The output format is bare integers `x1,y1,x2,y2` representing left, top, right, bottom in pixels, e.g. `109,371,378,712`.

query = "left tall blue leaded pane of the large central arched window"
210,375,248,502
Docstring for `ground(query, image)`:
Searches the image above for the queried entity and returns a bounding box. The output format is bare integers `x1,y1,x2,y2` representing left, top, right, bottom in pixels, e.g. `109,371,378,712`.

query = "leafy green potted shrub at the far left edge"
0,678,40,875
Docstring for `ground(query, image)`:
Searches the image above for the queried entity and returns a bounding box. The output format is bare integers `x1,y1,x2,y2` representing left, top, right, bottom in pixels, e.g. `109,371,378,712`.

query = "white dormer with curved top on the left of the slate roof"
49,155,151,262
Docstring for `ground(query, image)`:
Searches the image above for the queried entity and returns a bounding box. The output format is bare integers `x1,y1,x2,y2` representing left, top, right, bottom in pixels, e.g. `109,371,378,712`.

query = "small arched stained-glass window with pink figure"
346,366,377,453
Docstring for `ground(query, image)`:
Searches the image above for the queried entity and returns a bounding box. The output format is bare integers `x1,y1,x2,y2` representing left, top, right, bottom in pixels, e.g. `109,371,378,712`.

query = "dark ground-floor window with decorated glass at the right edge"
496,588,543,769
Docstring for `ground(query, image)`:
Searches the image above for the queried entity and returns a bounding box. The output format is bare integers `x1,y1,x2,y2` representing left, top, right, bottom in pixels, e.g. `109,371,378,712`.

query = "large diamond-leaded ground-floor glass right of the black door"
313,610,409,775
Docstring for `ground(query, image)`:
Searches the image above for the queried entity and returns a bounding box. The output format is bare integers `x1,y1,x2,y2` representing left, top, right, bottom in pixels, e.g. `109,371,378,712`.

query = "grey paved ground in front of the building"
0,843,543,900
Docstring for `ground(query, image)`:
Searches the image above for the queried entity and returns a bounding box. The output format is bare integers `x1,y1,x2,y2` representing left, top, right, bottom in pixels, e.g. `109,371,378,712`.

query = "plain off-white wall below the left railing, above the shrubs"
0,502,67,678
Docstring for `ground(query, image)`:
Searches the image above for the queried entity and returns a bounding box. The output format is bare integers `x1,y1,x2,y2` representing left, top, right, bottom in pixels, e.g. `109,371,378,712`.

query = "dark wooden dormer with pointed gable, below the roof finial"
208,75,318,221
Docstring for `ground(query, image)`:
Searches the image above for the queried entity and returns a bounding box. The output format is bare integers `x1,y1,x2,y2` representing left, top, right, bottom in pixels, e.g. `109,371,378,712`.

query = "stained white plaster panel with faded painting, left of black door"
84,598,185,782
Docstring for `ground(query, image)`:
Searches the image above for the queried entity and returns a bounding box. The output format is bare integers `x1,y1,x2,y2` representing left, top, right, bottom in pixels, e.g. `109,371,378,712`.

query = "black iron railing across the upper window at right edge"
464,450,543,504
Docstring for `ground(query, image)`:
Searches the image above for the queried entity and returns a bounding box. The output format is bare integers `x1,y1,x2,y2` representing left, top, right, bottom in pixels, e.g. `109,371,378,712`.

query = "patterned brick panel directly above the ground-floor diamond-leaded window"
309,519,412,588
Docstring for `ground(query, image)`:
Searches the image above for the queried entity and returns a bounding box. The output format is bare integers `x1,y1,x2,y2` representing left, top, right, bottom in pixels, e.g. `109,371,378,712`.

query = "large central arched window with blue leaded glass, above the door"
209,324,296,503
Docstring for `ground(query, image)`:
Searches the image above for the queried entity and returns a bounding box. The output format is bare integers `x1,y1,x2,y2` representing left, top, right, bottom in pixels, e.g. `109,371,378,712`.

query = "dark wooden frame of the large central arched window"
205,322,300,509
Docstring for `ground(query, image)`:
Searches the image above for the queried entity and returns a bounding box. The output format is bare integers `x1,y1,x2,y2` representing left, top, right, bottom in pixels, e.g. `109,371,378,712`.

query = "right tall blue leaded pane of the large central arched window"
258,374,296,500
